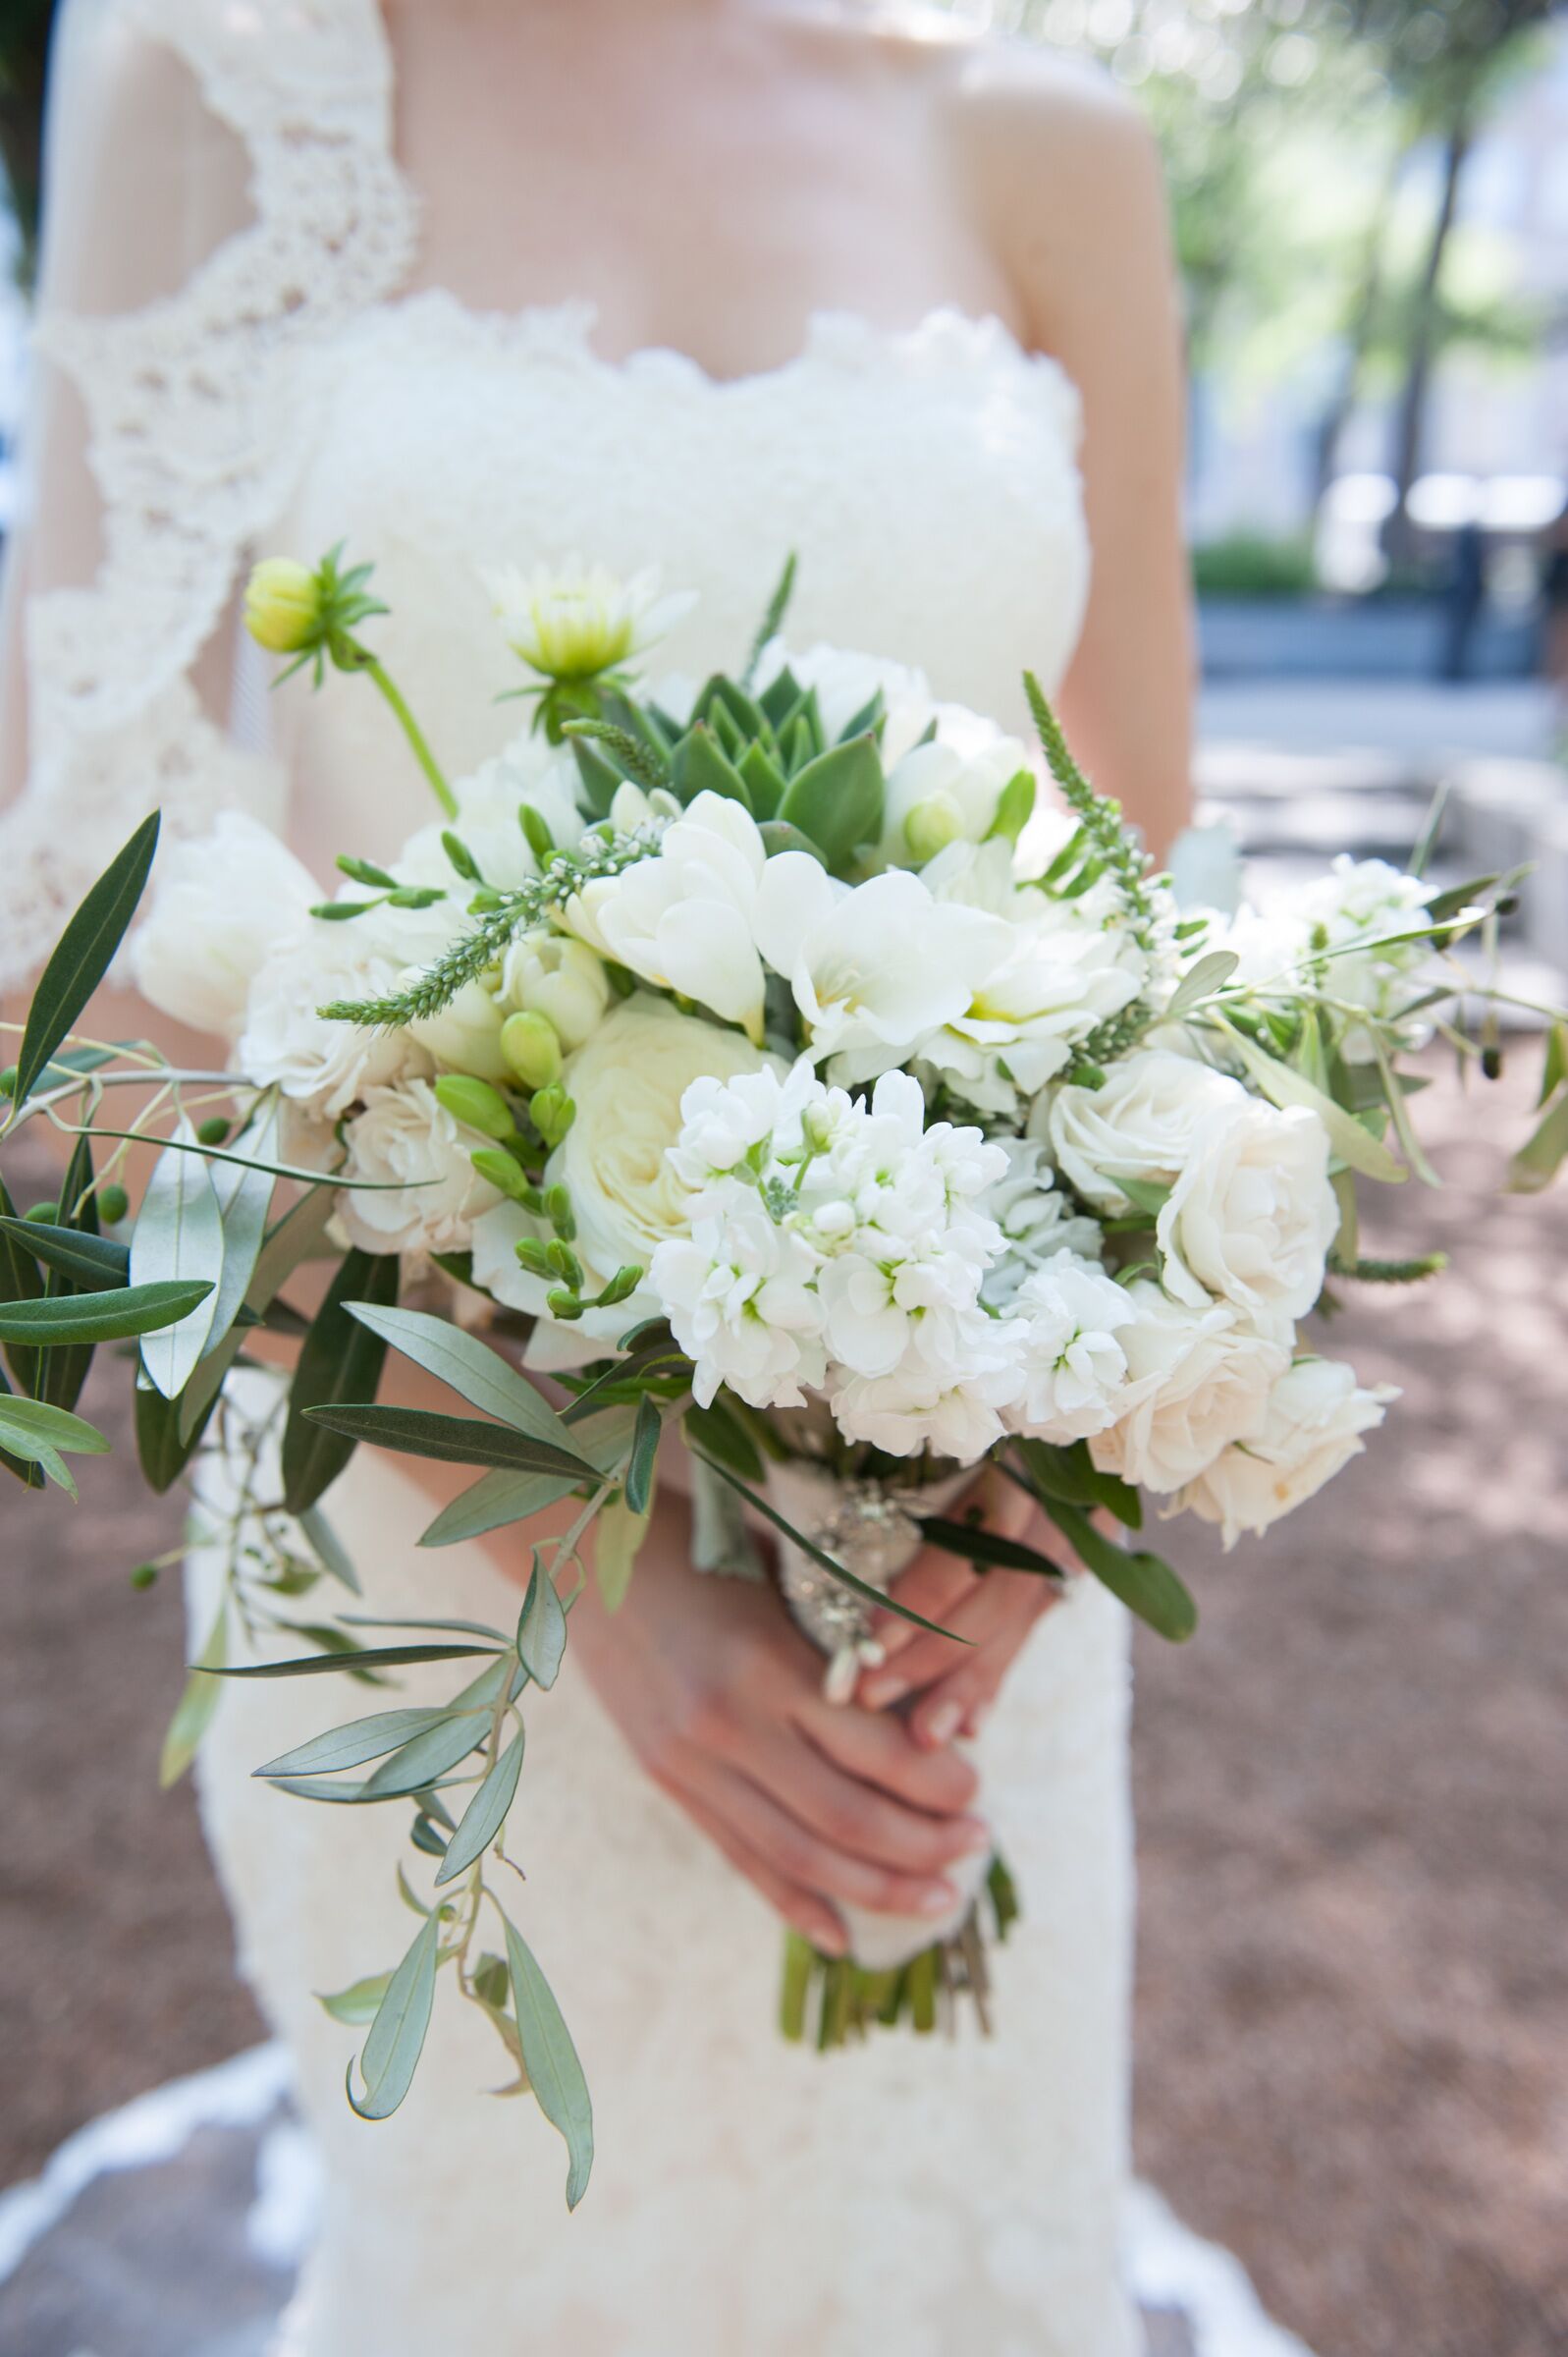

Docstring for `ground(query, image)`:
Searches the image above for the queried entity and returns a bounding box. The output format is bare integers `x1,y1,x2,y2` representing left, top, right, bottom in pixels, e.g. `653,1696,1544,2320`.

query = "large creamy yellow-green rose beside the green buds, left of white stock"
474,997,766,1365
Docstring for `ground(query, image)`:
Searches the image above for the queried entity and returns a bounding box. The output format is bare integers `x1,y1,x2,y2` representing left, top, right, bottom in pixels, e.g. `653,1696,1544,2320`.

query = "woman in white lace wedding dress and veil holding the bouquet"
0,0,1188,2357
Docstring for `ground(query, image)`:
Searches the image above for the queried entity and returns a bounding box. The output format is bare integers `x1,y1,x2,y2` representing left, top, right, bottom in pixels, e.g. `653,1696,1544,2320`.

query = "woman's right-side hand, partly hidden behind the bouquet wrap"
856,1475,1061,1751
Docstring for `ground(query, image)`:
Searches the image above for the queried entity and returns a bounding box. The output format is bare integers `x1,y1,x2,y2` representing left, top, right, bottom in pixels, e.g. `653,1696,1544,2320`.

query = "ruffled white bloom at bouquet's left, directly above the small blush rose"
234,917,431,1122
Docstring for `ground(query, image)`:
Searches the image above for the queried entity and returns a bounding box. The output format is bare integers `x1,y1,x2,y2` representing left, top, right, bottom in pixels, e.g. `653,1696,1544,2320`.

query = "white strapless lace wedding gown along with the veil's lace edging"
0,0,1134,2357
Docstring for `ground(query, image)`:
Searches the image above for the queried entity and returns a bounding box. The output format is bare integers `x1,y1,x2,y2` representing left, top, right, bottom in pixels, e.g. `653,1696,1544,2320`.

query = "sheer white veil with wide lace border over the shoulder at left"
0,0,415,985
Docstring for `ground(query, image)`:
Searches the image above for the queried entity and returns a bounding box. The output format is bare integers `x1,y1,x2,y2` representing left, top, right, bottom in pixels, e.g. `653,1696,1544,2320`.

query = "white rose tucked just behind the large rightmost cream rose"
1047,1049,1250,1212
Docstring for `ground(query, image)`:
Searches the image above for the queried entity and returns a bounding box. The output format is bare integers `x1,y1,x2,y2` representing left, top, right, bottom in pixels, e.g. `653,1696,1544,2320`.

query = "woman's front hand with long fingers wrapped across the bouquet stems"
570,1499,991,1954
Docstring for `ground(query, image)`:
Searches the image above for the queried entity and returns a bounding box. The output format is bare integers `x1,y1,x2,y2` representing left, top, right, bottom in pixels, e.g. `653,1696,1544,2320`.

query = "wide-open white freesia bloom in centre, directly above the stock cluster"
754,850,1009,1079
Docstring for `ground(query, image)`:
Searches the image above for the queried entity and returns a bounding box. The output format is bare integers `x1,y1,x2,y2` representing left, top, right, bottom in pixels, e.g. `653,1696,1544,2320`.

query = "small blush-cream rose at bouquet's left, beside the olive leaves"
337,1079,500,1251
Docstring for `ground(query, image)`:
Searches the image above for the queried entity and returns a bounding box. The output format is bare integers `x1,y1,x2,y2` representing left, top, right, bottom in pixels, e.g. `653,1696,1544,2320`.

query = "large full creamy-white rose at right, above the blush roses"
1156,1096,1339,1337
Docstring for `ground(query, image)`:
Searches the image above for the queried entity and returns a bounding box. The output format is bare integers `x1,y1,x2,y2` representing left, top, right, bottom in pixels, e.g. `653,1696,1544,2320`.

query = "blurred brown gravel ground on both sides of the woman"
0,1049,1568,2357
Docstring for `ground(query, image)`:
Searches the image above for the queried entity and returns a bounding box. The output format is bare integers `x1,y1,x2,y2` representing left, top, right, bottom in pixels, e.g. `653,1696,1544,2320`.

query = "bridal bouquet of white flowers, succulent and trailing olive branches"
0,542,1568,2202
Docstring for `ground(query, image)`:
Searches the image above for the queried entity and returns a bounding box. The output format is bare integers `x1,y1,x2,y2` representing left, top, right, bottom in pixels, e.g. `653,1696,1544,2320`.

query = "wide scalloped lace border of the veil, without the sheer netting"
0,0,417,980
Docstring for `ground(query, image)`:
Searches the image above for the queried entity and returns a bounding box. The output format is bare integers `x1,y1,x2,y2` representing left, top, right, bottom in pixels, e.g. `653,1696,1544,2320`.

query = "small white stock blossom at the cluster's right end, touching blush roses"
1006,1251,1139,1448
